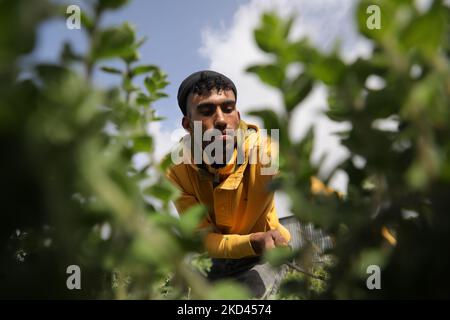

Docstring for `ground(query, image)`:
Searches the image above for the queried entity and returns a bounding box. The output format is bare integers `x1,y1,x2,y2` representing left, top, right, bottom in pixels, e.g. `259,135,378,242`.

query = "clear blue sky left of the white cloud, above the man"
34,0,248,129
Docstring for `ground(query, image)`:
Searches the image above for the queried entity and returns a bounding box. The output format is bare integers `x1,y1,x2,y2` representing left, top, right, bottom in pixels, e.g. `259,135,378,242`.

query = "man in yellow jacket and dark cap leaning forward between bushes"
167,71,290,298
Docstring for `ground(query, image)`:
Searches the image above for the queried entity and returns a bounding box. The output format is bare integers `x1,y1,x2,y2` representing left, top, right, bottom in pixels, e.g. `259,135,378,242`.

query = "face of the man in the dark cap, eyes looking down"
183,89,241,148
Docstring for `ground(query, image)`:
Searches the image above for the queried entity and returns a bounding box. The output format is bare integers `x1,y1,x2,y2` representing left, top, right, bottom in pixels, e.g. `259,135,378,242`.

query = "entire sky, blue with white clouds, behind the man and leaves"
32,0,380,199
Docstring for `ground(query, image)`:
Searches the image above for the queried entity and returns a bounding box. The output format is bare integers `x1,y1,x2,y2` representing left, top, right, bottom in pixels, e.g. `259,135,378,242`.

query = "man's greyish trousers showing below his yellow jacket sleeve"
208,257,288,299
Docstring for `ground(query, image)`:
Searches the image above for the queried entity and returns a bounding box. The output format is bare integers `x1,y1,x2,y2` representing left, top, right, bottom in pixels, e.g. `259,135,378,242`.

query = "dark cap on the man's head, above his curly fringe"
177,70,237,115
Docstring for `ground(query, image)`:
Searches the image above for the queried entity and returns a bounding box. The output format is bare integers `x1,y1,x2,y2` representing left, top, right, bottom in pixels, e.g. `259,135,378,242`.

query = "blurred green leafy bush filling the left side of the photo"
0,0,250,299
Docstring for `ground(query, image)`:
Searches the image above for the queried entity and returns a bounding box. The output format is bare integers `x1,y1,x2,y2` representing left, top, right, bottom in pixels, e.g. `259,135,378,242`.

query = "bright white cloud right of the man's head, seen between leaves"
199,0,372,216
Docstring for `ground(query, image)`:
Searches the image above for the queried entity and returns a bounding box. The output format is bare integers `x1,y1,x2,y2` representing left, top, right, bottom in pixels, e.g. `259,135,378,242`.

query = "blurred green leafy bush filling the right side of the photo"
248,0,450,298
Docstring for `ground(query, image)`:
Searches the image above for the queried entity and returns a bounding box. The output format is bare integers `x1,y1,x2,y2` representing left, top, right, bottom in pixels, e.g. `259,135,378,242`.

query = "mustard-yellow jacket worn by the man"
167,121,291,259
